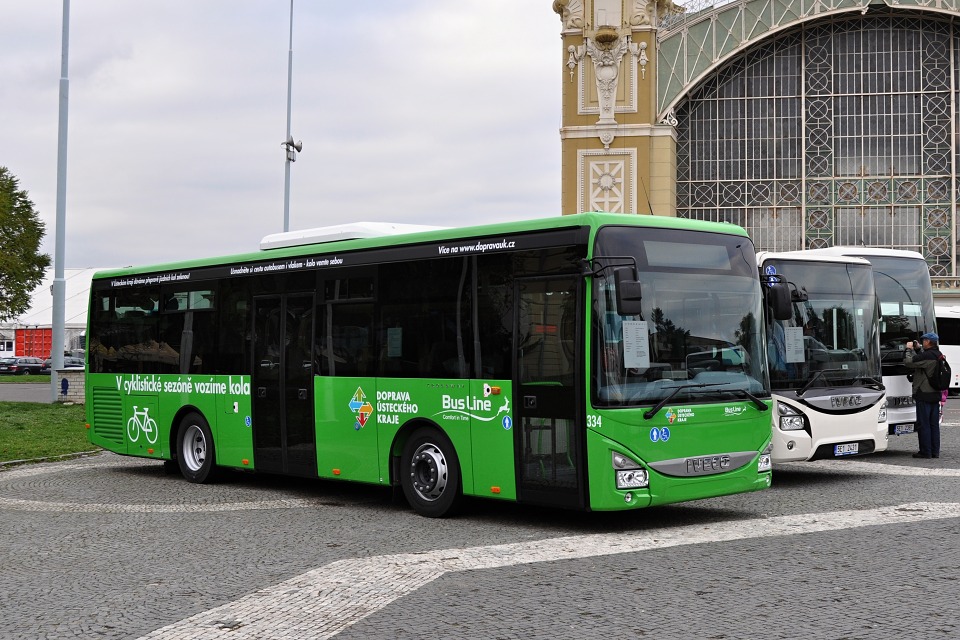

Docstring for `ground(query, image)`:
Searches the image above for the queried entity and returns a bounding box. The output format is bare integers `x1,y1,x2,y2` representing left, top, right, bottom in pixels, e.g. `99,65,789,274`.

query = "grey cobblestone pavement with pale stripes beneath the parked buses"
0,424,960,640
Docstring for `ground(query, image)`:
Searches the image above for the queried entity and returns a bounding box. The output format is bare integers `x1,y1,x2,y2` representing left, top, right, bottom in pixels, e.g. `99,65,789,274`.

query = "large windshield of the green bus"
591,227,769,406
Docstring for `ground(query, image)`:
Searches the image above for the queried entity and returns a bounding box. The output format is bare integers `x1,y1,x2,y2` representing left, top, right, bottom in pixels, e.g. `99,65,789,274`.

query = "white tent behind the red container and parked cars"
0,268,101,355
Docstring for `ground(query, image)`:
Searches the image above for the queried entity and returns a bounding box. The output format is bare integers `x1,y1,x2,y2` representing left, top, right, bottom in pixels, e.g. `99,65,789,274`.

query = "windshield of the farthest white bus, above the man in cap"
865,256,935,363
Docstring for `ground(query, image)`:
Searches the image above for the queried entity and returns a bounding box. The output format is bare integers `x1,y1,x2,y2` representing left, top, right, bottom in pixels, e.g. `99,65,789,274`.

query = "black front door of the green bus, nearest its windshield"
514,276,586,508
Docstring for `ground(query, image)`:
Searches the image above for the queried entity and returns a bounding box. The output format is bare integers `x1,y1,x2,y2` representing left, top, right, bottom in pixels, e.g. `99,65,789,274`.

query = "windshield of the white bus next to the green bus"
762,258,880,391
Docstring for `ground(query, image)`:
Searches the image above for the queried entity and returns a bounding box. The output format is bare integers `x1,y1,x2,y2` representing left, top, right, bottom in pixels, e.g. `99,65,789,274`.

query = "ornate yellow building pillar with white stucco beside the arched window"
554,0,676,216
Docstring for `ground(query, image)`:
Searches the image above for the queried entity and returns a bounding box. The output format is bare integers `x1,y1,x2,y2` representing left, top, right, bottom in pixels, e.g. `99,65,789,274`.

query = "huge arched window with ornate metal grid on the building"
676,13,960,276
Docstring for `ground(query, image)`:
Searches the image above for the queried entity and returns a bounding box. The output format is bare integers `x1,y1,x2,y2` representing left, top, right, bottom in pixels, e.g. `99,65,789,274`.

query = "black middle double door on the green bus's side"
253,293,317,477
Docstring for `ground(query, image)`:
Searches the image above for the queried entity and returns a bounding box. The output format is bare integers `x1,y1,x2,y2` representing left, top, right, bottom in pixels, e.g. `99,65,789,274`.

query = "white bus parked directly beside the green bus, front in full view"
757,251,888,464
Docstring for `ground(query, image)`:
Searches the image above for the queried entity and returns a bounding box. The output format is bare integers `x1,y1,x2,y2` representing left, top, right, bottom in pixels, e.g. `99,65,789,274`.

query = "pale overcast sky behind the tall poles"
0,0,567,267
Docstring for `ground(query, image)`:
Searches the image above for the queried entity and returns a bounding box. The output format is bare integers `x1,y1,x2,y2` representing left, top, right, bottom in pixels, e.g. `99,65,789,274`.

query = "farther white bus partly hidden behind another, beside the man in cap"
811,247,937,435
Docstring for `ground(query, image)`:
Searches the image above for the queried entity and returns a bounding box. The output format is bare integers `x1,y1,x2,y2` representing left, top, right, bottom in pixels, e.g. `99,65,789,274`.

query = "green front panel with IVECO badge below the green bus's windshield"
587,403,771,511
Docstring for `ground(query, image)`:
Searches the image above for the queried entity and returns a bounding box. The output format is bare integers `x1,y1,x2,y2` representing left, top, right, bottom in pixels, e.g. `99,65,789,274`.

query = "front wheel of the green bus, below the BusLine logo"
400,428,462,518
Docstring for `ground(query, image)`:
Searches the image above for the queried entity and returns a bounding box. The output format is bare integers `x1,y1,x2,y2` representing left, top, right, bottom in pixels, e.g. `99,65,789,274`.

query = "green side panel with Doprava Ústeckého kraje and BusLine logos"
314,377,516,499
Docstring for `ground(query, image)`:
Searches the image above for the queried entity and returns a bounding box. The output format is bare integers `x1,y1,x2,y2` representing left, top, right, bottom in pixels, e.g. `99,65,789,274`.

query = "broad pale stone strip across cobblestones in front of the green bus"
133,502,960,640
